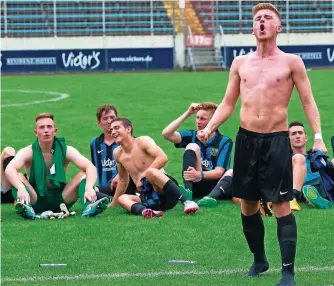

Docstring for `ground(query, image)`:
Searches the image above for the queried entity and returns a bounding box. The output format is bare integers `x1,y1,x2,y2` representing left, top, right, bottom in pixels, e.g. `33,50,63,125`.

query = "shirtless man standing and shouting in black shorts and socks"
198,3,327,285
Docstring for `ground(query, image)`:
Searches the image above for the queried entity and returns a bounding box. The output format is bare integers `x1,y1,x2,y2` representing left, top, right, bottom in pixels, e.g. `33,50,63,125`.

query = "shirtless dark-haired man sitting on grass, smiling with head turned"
109,118,199,218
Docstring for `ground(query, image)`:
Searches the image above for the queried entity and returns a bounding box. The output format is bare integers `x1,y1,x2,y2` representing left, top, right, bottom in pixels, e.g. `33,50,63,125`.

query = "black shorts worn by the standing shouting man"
233,127,293,202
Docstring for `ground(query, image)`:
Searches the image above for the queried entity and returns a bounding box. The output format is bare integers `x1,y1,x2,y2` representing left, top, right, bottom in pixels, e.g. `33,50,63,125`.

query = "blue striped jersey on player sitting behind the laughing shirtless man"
90,133,119,187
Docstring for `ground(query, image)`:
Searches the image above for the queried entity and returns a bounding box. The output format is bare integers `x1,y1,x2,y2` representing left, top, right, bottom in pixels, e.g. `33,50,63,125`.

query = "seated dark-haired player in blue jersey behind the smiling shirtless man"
90,104,136,200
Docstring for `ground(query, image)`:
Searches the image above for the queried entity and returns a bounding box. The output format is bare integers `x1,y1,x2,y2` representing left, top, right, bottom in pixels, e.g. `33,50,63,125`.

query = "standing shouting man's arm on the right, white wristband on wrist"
290,55,327,153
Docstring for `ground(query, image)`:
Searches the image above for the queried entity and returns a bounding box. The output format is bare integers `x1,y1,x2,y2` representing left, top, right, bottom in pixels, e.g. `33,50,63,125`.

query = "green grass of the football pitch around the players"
1,70,334,285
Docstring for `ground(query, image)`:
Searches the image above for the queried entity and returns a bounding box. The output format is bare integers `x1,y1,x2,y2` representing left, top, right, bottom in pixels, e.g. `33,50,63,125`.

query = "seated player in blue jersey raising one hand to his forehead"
162,102,233,199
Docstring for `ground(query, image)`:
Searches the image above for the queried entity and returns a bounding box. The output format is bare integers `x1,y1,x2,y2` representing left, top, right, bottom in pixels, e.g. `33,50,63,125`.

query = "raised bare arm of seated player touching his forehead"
162,103,199,144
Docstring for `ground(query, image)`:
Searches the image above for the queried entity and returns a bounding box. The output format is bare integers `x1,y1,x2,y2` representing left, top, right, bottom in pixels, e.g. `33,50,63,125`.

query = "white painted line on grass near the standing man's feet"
2,265,334,282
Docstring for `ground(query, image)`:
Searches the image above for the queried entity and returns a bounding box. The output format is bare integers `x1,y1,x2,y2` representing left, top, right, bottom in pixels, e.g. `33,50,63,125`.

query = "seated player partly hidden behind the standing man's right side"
289,121,332,210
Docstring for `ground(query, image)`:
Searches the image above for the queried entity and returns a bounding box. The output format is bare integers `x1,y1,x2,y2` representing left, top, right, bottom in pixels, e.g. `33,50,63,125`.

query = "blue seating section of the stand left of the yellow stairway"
1,0,173,37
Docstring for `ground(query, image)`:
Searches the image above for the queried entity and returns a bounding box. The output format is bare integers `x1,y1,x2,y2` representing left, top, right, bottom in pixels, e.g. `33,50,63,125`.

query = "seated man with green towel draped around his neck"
5,113,108,219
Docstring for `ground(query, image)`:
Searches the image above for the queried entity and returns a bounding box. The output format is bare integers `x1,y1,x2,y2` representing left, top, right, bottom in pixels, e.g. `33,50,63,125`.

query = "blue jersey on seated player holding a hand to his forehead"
174,130,233,171
